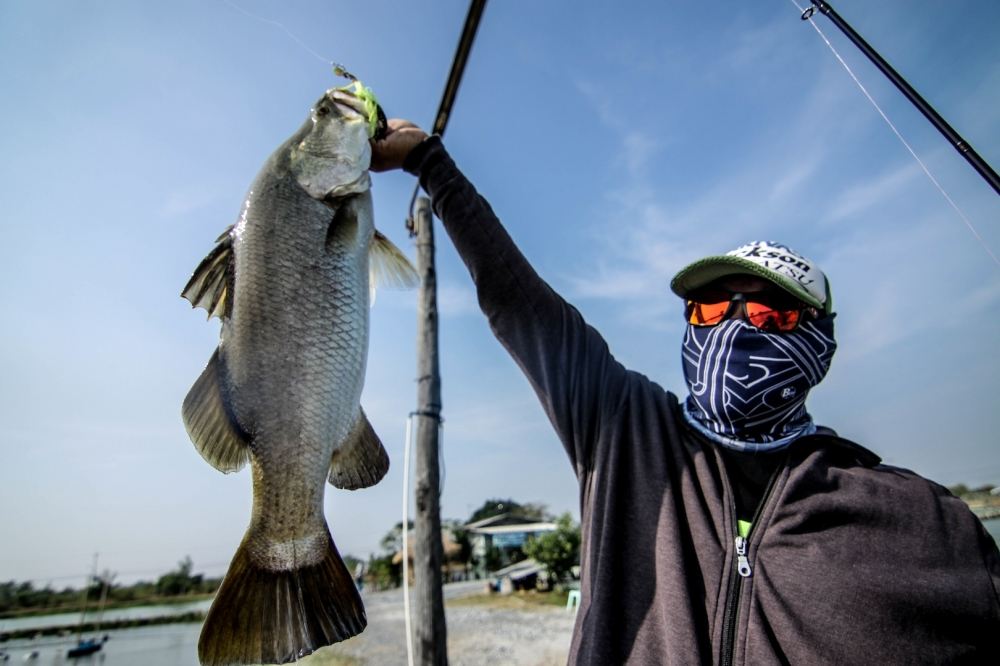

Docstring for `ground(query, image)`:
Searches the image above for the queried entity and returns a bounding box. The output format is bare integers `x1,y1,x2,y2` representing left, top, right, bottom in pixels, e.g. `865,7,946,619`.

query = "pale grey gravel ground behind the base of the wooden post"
297,581,574,666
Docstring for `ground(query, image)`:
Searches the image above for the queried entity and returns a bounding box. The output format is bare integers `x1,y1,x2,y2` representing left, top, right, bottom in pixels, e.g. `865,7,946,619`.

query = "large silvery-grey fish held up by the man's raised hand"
181,86,417,666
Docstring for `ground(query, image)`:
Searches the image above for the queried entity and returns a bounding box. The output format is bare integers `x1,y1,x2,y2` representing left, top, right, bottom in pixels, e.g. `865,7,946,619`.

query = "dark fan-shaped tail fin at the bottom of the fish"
198,530,368,666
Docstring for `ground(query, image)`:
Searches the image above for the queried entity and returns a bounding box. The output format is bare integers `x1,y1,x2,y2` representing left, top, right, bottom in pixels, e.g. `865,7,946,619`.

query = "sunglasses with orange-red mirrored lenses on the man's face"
684,292,819,333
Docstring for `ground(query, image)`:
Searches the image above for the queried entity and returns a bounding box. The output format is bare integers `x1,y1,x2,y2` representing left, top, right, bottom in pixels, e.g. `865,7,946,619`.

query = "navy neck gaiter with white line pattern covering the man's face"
682,315,837,451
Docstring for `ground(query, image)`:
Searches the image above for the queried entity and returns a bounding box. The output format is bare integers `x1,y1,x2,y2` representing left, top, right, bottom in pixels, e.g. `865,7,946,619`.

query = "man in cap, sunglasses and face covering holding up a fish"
372,120,1000,665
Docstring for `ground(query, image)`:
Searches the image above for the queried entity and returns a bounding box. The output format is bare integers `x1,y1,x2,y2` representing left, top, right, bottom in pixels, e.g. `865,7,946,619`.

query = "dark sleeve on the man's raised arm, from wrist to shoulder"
403,136,627,476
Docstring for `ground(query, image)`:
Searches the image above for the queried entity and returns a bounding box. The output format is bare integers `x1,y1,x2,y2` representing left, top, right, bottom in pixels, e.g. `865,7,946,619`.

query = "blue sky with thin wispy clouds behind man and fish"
0,0,1000,585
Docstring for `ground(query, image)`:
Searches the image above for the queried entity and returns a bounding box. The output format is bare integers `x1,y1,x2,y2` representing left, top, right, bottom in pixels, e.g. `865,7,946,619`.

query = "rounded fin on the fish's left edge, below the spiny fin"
181,348,250,474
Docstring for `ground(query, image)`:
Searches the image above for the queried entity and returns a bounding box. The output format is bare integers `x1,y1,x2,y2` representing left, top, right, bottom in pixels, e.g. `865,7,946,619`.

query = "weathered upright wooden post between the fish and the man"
413,197,448,666
